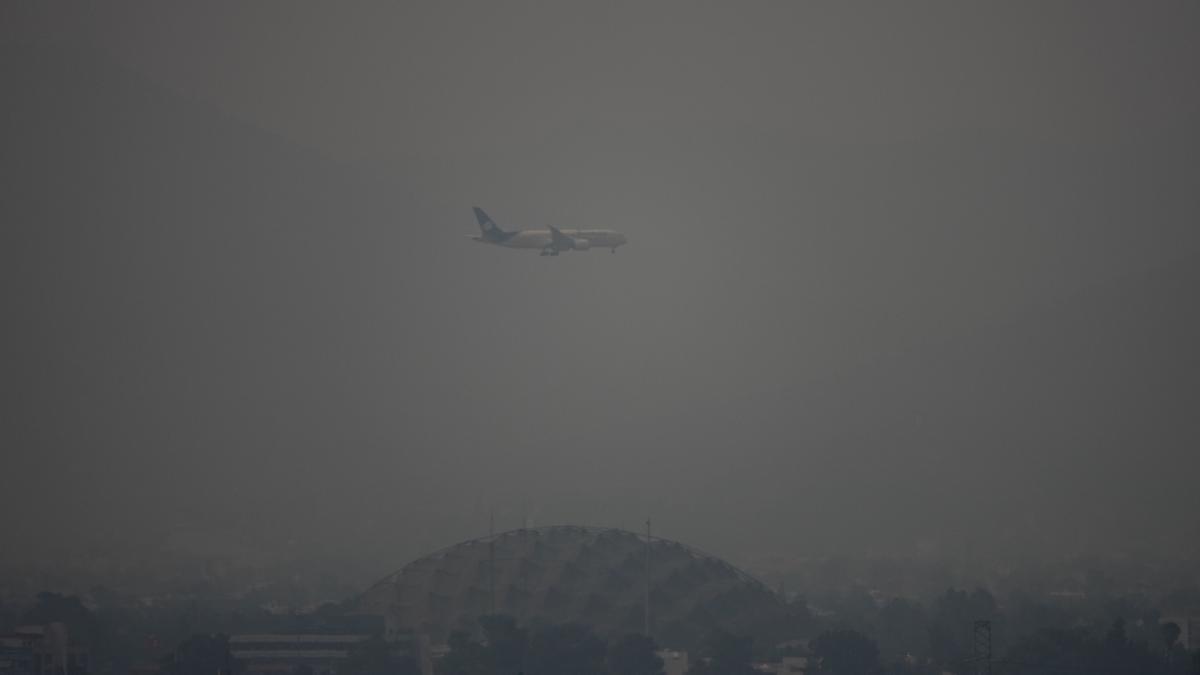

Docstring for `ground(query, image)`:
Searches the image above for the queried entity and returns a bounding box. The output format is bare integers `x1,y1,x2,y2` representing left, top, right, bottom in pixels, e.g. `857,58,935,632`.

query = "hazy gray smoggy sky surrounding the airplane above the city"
0,2,1200,569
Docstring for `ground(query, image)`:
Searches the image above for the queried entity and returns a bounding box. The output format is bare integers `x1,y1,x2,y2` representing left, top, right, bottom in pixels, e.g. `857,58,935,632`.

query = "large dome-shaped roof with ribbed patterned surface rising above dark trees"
358,526,784,644
